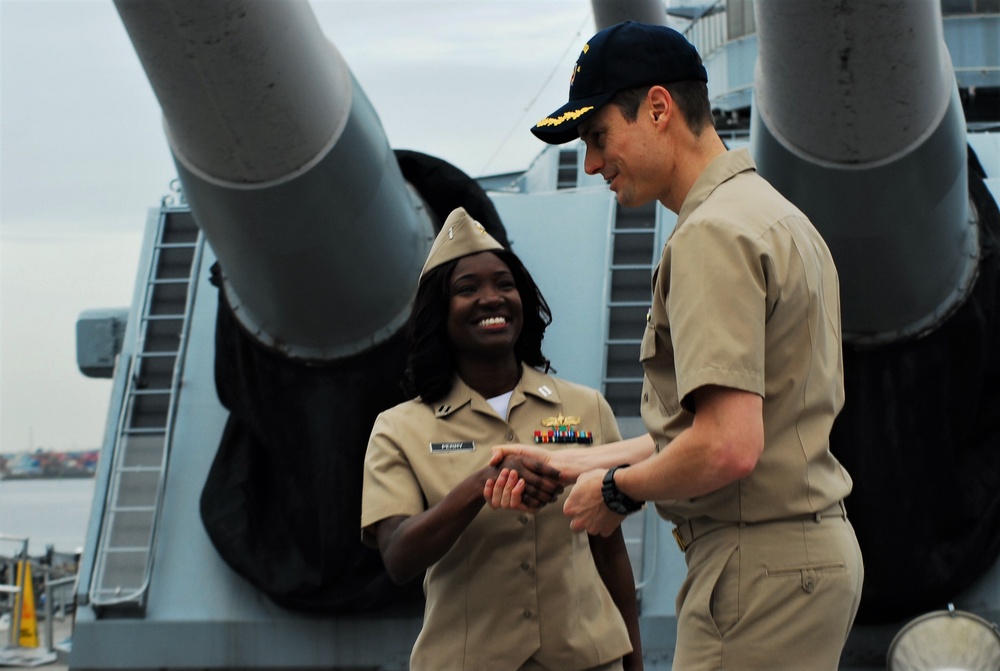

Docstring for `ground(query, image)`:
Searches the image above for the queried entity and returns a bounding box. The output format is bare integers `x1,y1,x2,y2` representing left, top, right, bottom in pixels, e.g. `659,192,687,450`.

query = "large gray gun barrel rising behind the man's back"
751,0,978,343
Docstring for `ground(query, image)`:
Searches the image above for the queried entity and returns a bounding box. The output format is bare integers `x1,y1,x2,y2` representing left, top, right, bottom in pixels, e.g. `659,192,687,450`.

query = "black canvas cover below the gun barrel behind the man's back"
831,156,1000,623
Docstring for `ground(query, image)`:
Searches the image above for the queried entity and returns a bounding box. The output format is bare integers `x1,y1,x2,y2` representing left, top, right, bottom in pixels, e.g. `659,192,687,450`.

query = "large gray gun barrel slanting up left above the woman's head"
115,0,434,359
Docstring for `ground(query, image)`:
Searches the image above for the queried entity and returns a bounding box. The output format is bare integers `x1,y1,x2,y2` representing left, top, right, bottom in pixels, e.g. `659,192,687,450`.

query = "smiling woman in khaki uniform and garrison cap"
361,208,642,671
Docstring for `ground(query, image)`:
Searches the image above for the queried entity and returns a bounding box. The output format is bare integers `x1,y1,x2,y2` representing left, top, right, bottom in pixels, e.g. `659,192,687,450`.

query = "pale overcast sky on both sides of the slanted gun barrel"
0,0,612,453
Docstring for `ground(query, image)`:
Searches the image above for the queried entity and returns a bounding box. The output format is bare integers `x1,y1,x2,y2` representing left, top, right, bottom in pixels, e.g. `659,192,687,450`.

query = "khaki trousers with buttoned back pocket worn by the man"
673,517,864,671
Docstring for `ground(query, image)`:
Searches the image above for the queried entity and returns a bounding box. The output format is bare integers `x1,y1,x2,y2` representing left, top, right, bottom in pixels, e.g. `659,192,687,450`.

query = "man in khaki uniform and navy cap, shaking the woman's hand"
486,22,863,671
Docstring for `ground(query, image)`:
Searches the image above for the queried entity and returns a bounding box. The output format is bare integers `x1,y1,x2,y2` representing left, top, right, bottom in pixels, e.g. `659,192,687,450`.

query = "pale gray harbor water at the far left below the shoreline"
0,478,95,557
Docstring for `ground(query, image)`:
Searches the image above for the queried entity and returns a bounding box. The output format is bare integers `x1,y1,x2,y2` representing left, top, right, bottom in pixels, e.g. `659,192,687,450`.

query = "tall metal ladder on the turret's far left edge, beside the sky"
89,206,202,616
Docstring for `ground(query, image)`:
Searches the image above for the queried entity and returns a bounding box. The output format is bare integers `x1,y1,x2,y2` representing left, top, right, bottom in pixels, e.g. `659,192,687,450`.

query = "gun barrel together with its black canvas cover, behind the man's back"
750,0,1000,621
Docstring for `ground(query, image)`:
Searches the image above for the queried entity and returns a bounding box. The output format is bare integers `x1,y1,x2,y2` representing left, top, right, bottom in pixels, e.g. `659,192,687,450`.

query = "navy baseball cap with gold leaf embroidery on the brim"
531,21,708,144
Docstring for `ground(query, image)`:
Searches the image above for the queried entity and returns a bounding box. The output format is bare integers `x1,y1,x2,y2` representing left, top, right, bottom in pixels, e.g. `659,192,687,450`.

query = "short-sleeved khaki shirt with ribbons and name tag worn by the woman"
361,366,631,671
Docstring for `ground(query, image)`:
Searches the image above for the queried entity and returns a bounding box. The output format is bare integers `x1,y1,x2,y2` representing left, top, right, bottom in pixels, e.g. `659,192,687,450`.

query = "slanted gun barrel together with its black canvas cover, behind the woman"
104,0,506,613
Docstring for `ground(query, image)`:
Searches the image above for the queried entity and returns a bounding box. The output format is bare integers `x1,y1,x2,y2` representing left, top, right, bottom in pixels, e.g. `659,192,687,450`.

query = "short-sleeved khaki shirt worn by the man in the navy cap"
640,149,852,522
